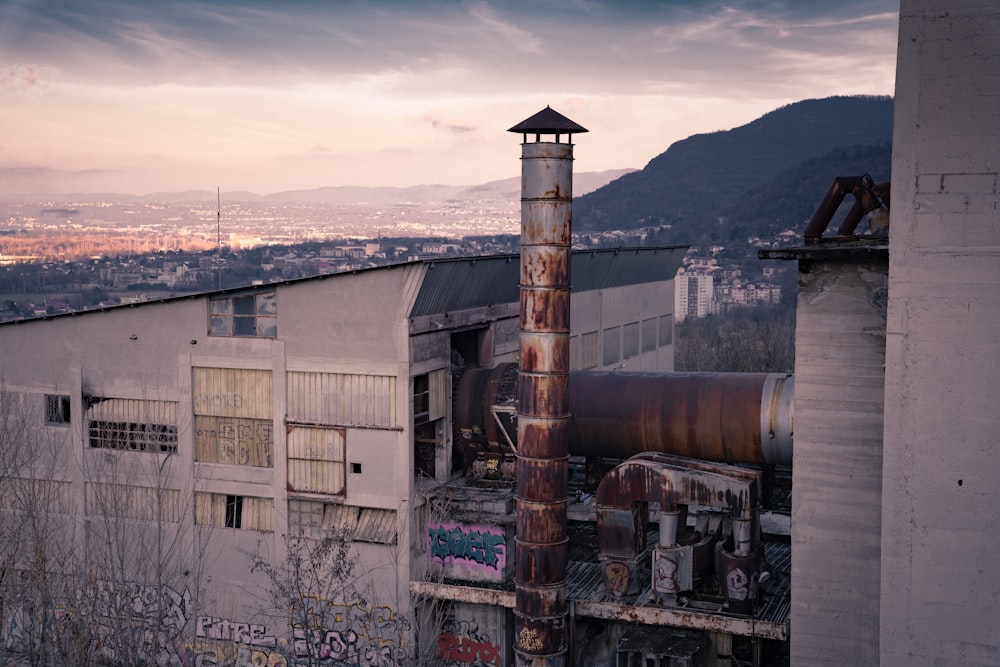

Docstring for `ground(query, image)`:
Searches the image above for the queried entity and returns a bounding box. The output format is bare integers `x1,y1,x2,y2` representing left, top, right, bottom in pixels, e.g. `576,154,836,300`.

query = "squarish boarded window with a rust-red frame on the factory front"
288,425,345,494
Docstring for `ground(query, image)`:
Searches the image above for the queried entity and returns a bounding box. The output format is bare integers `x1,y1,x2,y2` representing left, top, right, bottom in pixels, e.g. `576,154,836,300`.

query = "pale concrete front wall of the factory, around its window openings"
0,270,413,664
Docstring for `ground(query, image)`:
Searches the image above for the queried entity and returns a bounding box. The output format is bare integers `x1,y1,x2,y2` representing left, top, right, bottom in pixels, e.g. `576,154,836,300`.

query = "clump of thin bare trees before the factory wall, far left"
0,391,205,667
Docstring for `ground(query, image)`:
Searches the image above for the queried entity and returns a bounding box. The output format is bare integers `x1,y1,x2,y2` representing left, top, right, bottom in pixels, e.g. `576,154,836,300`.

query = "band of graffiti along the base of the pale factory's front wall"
0,582,406,667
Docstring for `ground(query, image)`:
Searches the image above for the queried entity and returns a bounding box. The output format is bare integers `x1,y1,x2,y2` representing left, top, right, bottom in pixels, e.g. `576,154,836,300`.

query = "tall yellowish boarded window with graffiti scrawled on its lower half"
192,368,274,468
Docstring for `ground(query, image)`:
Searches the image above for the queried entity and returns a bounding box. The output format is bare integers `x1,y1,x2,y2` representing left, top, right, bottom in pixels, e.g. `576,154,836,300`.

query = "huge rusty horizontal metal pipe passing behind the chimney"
454,364,795,465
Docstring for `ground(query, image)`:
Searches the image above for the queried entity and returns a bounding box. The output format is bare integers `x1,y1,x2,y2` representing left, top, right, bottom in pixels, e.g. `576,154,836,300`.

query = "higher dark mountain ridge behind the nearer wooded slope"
573,96,893,243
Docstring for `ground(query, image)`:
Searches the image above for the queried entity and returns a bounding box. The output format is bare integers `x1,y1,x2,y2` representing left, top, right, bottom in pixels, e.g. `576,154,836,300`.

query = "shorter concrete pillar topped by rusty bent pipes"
791,258,888,667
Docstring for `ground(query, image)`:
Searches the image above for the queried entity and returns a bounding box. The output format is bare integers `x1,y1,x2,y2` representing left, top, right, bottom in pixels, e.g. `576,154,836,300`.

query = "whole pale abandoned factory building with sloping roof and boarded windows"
0,248,684,665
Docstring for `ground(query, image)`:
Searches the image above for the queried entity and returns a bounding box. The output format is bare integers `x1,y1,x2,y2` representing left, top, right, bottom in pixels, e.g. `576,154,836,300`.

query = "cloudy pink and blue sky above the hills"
0,0,899,194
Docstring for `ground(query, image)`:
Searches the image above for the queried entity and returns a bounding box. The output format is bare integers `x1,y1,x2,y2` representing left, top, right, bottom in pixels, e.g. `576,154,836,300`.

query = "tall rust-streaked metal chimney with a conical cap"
509,107,587,667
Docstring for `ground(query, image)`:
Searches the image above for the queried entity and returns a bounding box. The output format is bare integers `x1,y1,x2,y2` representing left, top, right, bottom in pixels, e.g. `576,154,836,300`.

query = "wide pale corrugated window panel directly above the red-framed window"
288,371,399,428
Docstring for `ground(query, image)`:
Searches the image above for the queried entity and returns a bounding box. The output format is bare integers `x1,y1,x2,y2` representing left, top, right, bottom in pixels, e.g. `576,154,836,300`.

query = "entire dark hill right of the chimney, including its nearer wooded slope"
573,96,893,243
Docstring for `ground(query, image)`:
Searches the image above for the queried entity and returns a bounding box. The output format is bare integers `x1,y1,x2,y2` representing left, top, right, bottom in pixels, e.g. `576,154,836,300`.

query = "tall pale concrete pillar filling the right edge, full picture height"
884,0,1000,665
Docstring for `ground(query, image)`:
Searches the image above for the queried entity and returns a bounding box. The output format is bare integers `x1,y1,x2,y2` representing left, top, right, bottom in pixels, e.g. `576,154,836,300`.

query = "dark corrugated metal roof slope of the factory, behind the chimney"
410,246,687,317
